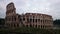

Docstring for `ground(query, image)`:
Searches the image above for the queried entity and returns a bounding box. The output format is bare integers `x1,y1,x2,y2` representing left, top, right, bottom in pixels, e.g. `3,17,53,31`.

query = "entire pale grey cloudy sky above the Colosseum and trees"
0,0,60,19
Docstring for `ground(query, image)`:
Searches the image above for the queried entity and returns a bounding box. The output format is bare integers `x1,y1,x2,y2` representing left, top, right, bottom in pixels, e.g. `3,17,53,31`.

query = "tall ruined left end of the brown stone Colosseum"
5,3,19,27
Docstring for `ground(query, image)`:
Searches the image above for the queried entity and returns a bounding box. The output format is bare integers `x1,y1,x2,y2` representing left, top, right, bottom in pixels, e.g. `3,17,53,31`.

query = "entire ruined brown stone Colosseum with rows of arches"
5,2,53,29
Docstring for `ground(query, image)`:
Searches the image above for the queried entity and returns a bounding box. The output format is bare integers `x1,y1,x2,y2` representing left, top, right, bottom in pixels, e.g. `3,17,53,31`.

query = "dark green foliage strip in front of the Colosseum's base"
0,27,60,34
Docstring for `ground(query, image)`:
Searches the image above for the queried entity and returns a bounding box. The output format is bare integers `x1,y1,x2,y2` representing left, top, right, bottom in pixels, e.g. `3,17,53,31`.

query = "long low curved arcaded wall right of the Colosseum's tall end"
20,13,53,29
